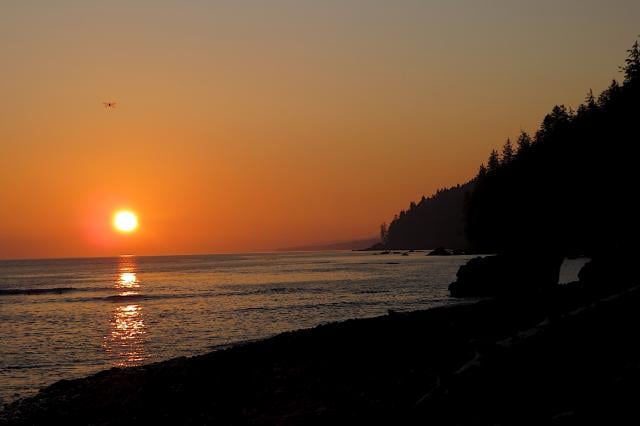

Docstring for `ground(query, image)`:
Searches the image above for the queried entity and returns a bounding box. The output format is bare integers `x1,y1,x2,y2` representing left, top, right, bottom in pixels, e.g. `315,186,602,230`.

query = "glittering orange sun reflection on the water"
103,256,146,367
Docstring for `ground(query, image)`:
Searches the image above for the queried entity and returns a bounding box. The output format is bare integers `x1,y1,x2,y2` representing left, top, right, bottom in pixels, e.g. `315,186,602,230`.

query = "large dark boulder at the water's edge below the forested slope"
449,254,563,297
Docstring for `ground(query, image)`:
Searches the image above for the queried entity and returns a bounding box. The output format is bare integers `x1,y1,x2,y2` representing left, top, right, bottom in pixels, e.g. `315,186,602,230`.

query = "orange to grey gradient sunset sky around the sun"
0,0,640,258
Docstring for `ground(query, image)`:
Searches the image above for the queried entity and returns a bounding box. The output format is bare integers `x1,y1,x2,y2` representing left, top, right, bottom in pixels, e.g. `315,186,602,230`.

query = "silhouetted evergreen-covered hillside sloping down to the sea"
381,41,640,254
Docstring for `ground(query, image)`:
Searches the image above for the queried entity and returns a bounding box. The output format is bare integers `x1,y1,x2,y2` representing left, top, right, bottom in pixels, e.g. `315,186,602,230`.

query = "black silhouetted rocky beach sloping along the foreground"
0,284,640,425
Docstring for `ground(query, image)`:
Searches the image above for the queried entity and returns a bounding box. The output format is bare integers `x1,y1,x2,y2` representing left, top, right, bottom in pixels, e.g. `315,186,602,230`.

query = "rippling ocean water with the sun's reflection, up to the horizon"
0,251,582,403
